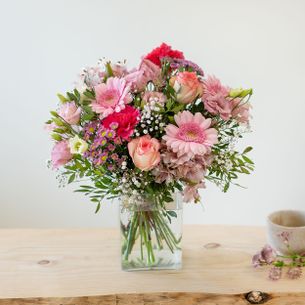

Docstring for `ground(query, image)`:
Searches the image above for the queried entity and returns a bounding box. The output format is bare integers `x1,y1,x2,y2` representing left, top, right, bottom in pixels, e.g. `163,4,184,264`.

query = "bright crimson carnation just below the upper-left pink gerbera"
102,105,140,140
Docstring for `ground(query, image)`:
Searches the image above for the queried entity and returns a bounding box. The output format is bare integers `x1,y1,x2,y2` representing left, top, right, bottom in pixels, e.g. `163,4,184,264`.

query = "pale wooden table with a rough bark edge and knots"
0,226,305,305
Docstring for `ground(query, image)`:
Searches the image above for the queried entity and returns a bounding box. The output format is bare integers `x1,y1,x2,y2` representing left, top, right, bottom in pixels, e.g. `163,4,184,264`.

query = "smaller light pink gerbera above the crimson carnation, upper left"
91,77,132,118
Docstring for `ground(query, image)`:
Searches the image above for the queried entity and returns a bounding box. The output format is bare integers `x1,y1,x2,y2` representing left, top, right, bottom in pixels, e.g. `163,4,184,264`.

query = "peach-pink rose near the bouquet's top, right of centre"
169,71,203,104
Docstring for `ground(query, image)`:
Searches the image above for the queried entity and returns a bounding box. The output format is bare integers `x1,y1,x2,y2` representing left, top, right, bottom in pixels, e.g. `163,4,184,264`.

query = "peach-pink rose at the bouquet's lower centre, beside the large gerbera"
128,135,160,171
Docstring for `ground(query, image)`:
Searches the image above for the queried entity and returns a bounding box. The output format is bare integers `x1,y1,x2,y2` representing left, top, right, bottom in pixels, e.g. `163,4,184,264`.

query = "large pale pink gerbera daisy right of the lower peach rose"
163,111,217,158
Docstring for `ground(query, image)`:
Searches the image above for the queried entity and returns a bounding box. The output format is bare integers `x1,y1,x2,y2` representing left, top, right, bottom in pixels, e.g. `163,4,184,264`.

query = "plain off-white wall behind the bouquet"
0,0,305,227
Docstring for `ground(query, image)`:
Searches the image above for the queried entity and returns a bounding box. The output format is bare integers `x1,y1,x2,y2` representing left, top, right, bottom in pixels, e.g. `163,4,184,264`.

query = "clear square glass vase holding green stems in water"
120,193,183,271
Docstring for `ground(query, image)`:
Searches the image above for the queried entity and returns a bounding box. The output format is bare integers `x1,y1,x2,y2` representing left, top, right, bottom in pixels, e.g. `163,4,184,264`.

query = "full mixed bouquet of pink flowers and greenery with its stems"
47,43,254,263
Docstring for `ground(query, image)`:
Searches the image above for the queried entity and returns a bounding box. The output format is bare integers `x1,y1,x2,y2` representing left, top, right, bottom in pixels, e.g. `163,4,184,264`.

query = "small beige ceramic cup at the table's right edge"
267,210,305,254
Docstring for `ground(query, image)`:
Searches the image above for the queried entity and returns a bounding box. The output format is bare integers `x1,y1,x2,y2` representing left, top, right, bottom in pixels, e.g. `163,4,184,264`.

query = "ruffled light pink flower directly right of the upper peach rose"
202,76,232,120
